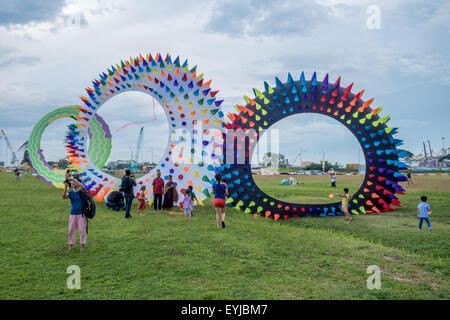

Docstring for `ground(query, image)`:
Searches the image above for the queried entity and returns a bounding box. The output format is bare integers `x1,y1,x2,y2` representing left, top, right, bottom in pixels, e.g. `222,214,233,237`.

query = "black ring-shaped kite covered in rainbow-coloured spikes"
219,72,407,220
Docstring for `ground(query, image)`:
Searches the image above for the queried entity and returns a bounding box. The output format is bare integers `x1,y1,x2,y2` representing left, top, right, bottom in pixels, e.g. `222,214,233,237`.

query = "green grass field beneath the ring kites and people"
0,173,450,299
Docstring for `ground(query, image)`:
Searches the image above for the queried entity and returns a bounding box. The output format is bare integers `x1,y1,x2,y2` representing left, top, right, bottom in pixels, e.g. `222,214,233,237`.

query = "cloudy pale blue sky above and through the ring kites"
0,0,450,163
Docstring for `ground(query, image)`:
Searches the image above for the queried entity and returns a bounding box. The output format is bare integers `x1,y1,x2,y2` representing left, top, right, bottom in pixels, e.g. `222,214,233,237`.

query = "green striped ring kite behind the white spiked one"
27,106,111,188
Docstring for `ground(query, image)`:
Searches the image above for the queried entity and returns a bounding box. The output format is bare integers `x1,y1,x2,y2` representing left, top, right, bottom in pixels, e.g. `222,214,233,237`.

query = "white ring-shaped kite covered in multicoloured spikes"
69,53,224,202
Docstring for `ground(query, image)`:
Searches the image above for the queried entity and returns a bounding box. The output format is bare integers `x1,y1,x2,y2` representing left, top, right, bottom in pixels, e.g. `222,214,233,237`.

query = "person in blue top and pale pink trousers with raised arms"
62,178,87,252
